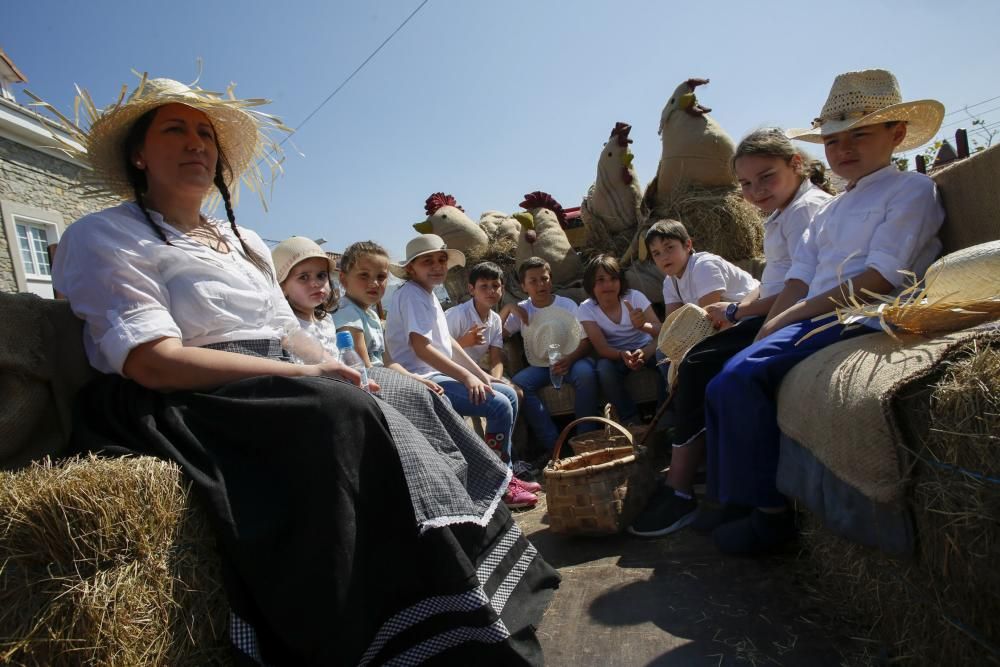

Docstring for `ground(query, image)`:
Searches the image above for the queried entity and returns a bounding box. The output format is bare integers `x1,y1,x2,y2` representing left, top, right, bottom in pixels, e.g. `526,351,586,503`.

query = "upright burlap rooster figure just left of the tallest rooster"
580,123,642,239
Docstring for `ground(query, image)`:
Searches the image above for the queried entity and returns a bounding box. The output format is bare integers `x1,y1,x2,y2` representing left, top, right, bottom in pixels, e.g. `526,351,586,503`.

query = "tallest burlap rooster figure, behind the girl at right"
656,79,736,203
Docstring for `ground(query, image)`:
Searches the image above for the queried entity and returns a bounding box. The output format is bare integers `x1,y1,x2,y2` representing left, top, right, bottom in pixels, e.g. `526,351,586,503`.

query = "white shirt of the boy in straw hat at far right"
787,165,944,299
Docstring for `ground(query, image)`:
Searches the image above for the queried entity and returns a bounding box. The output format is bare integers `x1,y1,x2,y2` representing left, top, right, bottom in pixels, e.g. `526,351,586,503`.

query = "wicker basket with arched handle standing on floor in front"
545,417,655,535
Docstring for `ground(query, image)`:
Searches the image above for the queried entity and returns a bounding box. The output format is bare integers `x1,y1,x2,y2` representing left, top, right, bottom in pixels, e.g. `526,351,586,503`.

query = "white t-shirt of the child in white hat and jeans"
385,280,451,377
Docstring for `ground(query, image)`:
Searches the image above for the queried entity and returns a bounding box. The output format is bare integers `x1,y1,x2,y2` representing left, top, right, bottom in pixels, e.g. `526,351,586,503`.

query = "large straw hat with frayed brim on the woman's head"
25,73,292,202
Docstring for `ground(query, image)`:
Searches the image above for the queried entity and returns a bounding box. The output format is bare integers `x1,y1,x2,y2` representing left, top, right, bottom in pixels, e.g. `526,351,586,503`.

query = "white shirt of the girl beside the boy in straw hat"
760,178,833,299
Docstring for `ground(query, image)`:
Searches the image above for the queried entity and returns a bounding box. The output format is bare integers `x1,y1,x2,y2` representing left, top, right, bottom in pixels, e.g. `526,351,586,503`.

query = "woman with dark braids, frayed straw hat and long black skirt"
43,70,558,665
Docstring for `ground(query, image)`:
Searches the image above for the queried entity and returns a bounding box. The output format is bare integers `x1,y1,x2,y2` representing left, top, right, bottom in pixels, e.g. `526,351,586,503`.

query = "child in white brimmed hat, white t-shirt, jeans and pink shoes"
386,234,541,508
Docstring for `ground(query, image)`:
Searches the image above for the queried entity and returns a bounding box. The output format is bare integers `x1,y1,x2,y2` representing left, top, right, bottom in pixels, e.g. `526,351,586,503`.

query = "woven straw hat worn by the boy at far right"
785,69,944,153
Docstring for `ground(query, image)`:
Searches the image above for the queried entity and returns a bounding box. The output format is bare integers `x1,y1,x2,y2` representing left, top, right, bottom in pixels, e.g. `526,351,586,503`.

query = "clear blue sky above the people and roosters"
7,0,1000,257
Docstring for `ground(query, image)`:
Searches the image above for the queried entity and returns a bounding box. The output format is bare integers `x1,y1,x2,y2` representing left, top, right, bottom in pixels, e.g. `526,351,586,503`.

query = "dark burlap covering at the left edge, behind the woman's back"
0,293,93,469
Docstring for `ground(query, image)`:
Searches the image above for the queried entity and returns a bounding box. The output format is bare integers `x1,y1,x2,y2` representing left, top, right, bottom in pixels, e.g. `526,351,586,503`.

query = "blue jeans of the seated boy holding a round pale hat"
511,358,598,452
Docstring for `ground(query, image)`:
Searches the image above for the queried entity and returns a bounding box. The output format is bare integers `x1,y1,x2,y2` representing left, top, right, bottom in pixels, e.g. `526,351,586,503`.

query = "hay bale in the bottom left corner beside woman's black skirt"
0,457,229,665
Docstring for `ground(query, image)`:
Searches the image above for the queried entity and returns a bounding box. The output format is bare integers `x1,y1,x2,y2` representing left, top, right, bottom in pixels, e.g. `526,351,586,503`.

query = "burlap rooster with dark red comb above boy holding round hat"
516,190,583,285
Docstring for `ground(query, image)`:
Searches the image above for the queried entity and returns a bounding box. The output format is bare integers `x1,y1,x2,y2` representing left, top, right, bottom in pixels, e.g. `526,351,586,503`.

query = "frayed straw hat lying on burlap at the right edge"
803,241,1000,340
